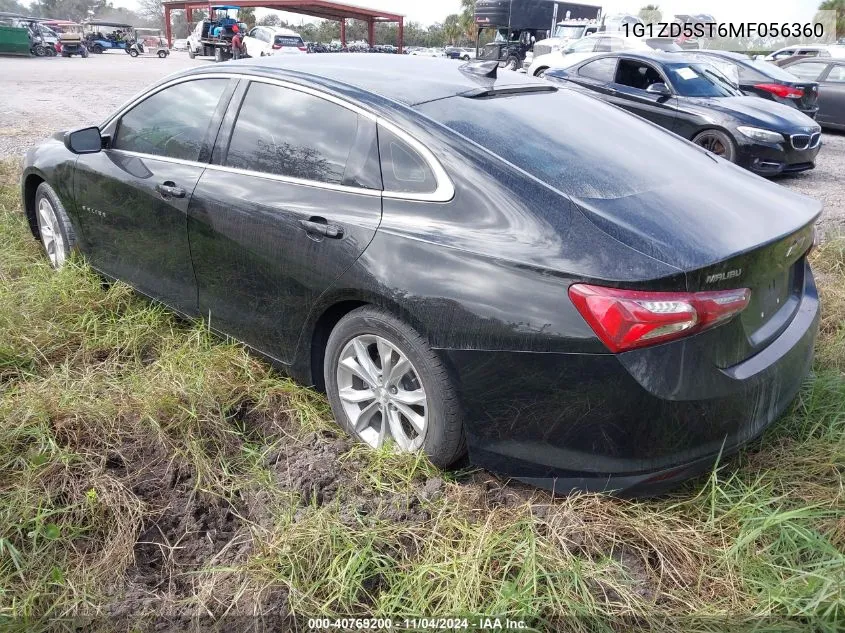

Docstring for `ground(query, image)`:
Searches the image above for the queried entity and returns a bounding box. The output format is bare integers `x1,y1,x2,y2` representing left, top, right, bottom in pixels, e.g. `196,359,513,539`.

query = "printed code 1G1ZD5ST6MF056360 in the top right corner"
621,22,826,39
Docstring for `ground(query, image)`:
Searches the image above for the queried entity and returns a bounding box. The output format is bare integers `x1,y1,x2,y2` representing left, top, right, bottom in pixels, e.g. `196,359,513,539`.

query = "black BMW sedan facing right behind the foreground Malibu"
544,52,821,176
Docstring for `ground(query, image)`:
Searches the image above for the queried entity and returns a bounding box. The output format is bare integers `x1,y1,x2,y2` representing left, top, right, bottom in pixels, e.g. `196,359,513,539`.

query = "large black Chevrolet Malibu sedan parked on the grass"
22,55,820,494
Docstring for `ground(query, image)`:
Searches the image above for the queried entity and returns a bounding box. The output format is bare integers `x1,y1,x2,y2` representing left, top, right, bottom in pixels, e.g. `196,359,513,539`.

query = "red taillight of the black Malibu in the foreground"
569,284,751,353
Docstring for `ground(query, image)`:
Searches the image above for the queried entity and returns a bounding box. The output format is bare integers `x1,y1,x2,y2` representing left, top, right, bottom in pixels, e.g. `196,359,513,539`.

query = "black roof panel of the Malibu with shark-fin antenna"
186,54,549,106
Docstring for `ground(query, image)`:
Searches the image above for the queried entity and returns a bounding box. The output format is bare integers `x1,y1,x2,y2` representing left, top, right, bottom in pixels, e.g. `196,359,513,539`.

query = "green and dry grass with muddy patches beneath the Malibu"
0,157,845,631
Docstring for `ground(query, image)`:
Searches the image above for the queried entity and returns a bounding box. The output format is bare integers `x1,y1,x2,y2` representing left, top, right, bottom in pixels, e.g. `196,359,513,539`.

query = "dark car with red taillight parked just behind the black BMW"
683,50,819,118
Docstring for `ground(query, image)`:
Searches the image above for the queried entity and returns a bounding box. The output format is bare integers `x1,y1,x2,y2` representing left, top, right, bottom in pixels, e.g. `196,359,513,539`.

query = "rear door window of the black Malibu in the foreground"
225,82,358,184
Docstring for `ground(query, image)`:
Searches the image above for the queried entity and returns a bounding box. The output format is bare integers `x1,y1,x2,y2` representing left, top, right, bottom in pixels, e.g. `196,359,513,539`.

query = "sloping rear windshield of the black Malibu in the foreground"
417,89,713,198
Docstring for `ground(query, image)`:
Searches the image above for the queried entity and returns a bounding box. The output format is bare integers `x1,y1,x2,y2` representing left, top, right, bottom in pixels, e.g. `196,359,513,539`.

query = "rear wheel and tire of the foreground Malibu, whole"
323,306,465,468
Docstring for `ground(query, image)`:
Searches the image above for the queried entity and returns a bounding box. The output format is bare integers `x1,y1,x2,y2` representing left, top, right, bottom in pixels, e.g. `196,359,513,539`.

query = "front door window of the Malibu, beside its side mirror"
112,79,229,160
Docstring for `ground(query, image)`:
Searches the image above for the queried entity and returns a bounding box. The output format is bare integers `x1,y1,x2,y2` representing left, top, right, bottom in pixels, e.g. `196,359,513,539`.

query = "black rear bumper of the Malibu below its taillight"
443,267,819,495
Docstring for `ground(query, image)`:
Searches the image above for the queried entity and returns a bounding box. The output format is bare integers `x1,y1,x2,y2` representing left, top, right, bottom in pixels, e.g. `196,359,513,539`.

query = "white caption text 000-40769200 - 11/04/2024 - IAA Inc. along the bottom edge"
308,617,528,631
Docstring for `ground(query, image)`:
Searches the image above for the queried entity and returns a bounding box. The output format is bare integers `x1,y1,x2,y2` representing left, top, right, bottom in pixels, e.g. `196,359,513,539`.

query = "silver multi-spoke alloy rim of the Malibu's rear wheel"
337,334,429,451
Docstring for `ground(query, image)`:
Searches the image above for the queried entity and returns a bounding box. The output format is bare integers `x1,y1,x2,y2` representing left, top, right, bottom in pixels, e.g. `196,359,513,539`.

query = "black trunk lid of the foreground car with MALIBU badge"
577,161,821,367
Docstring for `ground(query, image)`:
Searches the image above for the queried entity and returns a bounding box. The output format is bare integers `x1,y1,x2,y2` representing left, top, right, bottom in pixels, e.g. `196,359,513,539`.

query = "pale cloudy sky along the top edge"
113,0,820,25
